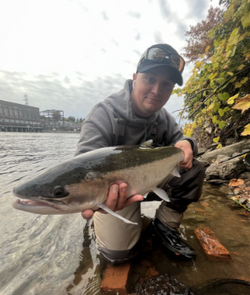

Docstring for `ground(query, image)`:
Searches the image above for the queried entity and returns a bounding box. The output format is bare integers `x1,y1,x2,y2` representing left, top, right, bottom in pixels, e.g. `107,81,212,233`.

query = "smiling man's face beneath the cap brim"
131,67,175,117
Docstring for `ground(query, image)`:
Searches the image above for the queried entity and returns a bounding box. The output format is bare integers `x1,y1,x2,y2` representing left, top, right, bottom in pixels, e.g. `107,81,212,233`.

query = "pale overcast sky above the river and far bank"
0,0,219,122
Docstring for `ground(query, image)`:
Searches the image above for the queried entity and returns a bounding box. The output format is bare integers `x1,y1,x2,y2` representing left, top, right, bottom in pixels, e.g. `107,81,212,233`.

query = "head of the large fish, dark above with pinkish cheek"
13,165,108,214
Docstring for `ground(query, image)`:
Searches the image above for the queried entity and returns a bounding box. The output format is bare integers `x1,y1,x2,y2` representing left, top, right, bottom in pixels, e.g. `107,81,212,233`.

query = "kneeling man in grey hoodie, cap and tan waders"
76,44,204,263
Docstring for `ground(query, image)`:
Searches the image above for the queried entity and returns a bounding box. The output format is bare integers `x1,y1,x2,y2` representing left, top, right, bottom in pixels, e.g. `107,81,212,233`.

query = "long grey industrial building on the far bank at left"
0,100,43,132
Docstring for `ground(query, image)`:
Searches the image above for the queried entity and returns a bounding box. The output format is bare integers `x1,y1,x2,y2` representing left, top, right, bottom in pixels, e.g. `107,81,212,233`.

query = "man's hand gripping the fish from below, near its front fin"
82,182,143,219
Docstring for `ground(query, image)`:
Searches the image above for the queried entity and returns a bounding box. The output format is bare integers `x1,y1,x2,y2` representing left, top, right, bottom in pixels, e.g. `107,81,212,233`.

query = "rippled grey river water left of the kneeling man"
0,132,98,295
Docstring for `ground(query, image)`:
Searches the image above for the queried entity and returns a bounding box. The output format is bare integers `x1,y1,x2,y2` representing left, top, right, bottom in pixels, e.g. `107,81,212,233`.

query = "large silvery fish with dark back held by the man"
13,145,183,225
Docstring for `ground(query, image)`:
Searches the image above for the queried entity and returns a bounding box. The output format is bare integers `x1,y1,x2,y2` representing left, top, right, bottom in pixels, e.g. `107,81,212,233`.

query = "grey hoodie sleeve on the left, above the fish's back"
75,103,116,156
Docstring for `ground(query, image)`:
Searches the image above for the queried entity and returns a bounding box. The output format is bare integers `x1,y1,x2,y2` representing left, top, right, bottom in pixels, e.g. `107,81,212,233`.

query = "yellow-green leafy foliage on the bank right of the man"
180,0,250,144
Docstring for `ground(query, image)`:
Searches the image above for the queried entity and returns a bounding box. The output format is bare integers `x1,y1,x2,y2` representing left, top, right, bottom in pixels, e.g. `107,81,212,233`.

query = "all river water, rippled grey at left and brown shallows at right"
0,133,250,295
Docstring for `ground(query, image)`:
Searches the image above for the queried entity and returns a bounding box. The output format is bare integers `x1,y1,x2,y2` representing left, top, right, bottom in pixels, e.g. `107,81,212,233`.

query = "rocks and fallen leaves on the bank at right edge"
197,139,250,211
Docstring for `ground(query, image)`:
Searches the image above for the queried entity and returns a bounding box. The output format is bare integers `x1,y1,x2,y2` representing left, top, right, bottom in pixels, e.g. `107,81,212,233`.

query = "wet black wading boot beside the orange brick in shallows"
150,218,196,258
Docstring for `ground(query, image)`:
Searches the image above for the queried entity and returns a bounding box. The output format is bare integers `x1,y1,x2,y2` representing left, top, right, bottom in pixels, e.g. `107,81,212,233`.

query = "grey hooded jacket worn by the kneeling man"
75,80,197,155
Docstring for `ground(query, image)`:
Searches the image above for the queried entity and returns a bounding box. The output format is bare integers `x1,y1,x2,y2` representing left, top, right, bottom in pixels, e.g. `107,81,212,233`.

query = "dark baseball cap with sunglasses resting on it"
136,44,185,86
